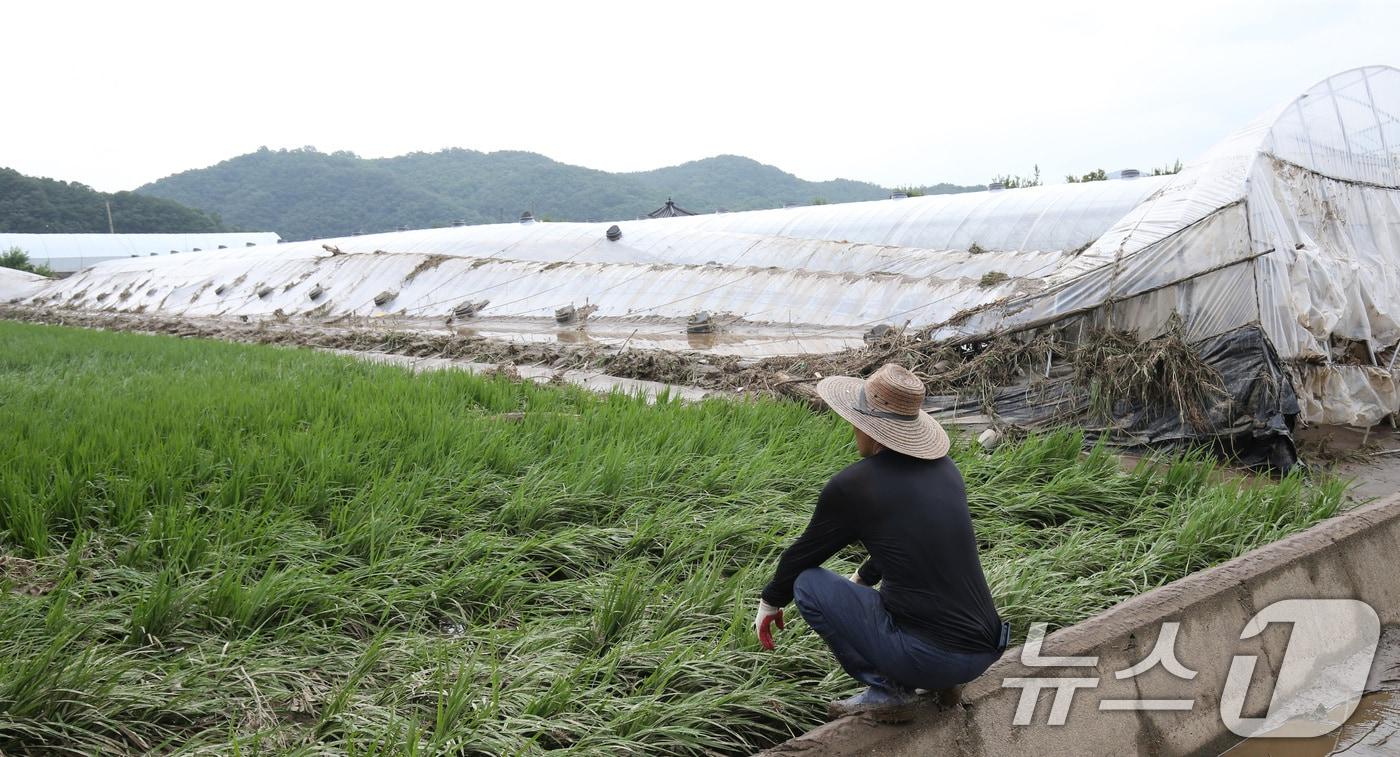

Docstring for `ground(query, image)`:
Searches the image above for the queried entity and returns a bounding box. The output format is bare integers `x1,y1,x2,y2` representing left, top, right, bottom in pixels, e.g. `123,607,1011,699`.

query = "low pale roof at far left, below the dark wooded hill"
0,231,280,273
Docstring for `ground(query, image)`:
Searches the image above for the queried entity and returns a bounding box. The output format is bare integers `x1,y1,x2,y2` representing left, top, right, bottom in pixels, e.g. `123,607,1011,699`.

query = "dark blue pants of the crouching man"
792,568,1001,690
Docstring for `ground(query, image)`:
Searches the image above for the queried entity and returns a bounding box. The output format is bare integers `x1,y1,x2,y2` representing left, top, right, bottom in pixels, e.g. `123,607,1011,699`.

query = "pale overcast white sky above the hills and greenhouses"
0,0,1400,190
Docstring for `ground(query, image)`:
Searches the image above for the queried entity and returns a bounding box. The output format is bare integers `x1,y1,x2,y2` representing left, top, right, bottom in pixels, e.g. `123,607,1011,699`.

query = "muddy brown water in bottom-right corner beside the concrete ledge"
1221,691,1400,757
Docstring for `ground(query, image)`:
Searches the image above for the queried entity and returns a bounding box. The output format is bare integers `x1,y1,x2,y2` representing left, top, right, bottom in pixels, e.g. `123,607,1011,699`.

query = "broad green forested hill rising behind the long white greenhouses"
137,148,981,239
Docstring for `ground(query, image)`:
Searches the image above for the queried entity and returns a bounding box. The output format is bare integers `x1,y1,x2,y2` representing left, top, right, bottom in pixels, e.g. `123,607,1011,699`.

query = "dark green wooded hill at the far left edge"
0,168,227,234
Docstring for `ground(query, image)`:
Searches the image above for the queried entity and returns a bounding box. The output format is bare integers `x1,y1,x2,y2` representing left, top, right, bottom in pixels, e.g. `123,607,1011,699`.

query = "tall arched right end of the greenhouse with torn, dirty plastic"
942,67,1400,424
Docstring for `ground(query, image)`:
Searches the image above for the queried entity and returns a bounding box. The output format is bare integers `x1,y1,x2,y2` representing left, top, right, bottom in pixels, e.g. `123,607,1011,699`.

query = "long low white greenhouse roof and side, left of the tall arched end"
27,179,1162,350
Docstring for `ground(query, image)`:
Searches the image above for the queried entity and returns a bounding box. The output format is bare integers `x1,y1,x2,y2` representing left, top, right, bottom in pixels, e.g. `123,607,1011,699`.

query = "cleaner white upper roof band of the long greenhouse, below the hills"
76,176,1166,277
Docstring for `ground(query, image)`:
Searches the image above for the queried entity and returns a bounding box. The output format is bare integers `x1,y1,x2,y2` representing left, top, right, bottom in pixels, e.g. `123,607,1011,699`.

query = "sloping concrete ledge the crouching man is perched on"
766,495,1400,757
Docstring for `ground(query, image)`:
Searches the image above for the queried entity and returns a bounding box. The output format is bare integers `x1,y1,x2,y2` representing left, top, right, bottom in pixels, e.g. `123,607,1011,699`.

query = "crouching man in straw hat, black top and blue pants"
755,364,1009,722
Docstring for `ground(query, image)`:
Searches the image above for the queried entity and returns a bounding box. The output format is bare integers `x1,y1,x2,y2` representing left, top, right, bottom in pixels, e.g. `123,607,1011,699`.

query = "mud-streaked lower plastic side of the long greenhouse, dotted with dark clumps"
38,243,1040,327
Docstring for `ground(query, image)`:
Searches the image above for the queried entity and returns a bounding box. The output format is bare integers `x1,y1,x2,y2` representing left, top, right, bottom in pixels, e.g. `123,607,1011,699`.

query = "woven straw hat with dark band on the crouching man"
816,362,948,460
